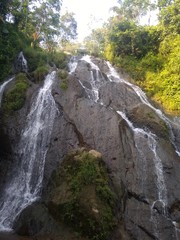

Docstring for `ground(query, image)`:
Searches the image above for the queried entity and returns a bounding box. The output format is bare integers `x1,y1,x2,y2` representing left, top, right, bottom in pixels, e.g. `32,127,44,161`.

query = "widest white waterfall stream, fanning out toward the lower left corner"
0,72,58,230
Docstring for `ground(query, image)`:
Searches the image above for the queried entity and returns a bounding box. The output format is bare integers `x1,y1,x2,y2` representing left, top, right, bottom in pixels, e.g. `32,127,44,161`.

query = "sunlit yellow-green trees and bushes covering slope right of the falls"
85,0,180,115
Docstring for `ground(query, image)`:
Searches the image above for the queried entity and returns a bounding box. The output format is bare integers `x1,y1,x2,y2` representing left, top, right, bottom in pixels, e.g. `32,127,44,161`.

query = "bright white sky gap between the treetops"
61,0,117,41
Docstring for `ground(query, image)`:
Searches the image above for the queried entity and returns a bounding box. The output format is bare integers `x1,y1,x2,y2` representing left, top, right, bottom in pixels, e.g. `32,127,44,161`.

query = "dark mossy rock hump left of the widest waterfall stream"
2,73,29,114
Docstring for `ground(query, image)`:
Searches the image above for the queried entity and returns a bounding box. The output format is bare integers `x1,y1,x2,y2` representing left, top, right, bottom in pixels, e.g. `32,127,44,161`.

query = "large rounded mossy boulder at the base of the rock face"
47,150,116,240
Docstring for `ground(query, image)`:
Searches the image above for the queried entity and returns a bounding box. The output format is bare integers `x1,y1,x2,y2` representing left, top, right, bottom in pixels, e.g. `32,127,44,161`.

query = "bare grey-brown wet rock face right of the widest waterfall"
1,56,180,240
